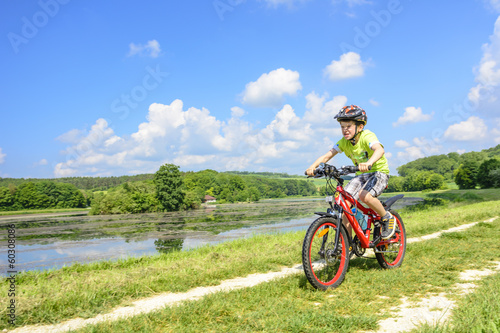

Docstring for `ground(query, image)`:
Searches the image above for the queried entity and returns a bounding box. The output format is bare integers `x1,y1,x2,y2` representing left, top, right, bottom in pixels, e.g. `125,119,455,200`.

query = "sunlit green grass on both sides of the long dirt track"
0,188,500,332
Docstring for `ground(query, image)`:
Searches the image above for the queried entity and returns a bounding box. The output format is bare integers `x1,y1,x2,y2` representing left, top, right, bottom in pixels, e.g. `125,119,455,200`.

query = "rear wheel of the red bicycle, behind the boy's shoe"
375,210,406,269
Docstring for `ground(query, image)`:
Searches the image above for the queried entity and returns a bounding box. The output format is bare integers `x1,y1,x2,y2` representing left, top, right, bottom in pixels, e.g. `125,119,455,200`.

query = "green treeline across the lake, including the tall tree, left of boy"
90,164,317,214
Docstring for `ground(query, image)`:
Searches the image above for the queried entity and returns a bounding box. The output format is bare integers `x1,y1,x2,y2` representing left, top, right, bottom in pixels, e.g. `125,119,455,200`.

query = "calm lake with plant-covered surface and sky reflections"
0,198,419,275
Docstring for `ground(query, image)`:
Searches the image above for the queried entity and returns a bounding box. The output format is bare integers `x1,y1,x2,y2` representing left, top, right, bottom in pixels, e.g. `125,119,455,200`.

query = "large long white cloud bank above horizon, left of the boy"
54,92,352,177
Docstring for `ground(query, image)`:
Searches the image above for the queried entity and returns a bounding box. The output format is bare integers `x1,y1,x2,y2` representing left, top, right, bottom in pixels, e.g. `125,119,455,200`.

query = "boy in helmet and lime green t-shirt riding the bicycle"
306,105,396,239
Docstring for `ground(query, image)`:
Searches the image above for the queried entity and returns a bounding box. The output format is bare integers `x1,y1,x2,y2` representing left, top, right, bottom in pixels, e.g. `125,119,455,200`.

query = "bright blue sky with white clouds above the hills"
0,0,500,178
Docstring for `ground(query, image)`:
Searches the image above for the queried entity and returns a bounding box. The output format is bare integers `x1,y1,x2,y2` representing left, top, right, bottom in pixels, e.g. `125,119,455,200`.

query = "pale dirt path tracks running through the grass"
10,217,500,333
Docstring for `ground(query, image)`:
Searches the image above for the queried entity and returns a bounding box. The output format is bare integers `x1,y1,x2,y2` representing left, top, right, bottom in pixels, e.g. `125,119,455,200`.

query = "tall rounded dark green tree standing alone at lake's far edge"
153,164,185,211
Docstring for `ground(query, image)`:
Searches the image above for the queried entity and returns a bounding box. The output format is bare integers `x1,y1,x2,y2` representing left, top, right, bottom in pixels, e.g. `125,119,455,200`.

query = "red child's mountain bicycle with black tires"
302,163,406,290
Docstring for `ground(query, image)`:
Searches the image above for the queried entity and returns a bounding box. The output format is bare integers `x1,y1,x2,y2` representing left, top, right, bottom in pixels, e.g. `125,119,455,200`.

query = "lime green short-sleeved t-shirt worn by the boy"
333,130,389,175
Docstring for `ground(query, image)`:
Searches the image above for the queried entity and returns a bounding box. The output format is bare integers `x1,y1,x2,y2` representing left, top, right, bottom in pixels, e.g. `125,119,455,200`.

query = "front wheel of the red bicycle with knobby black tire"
302,217,349,290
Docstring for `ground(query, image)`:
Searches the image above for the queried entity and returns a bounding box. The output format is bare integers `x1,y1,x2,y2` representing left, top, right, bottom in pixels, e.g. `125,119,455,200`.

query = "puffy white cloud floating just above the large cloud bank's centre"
242,68,302,107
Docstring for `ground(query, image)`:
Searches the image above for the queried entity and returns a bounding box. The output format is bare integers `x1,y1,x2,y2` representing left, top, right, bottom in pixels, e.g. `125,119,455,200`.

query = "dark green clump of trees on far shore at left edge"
0,180,89,211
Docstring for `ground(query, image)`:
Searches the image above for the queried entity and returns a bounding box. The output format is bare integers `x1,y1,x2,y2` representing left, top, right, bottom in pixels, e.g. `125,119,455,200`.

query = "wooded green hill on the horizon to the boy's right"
398,145,500,180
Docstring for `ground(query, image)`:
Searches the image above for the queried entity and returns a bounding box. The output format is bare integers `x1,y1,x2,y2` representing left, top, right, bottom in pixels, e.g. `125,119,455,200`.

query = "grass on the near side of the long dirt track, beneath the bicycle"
72,214,500,332
